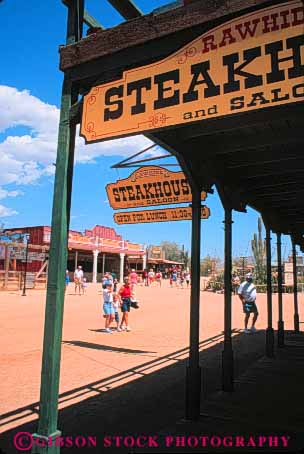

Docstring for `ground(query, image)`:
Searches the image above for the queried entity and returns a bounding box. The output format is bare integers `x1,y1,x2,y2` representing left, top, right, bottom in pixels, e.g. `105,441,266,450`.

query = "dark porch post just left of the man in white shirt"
222,207,233,391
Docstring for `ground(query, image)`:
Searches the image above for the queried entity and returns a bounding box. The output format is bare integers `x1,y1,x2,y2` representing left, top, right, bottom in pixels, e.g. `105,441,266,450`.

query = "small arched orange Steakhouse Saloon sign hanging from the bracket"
106,166,206,210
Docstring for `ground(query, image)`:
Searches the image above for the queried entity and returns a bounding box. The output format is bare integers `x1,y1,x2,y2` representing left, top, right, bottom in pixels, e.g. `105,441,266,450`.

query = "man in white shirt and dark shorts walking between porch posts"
238,273,259,334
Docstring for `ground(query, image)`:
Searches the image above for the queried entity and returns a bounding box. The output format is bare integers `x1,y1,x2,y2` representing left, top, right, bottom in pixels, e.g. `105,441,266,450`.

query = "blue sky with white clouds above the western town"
0,0,290,257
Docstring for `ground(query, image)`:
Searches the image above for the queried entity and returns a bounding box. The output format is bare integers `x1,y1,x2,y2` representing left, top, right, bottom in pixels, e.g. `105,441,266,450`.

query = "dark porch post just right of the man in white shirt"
265,224,274,358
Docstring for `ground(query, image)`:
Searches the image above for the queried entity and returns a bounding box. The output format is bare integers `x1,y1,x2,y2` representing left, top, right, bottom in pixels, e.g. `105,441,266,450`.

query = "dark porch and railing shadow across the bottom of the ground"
0,331,304,454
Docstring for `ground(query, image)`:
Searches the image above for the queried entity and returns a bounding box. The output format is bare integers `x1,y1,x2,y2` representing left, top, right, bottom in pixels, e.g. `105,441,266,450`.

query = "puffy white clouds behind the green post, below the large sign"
0,85,154,184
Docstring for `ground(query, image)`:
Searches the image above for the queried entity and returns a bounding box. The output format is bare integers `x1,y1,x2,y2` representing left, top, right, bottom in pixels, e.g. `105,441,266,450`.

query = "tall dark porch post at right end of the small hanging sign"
185,186,201,421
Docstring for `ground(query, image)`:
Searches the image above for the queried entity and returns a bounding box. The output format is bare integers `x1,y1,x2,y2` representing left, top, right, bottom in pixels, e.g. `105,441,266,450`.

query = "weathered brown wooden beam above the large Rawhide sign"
60,0,265,71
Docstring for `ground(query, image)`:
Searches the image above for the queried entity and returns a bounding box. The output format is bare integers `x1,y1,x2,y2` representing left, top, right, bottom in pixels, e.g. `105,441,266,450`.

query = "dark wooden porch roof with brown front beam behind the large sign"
60,0,304,250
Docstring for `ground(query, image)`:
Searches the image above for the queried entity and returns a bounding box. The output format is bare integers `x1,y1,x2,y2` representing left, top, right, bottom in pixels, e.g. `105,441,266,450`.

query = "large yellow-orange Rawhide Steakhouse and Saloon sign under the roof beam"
81,1,304,142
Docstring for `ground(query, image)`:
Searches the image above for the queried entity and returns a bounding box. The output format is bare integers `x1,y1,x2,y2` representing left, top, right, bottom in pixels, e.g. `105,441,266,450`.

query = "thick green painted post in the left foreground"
32,81,75,454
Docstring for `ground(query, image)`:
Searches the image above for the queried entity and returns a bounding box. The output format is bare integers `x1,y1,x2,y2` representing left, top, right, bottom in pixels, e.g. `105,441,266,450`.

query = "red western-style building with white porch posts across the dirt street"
0,225,146,282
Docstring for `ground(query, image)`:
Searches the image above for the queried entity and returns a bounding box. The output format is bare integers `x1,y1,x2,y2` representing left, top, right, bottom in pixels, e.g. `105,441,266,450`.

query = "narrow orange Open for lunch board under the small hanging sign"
114,205,210,224
